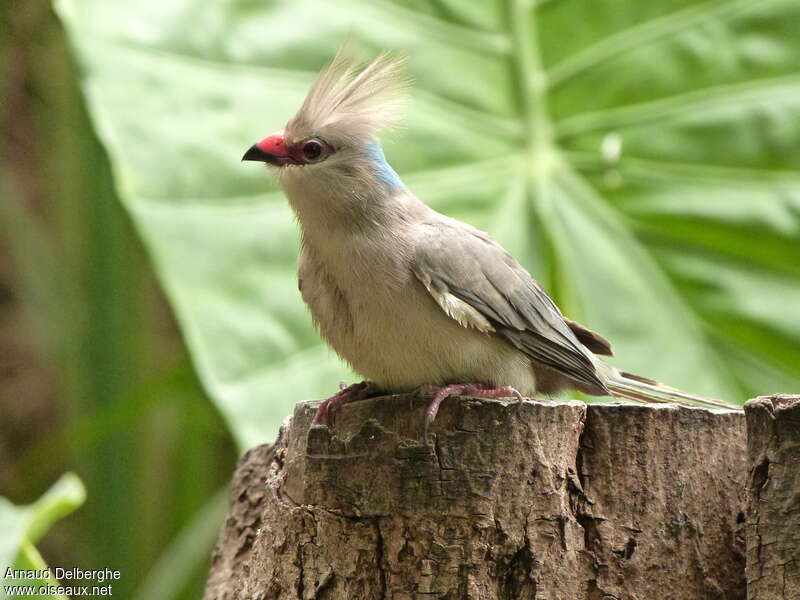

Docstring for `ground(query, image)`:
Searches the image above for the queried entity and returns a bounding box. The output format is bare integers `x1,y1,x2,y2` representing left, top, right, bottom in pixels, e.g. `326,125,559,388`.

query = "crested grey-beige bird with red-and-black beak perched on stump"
242,50,734,439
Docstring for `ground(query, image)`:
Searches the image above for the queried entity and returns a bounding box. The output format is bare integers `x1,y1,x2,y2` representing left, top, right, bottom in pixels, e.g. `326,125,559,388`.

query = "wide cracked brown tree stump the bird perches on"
205,396,746,600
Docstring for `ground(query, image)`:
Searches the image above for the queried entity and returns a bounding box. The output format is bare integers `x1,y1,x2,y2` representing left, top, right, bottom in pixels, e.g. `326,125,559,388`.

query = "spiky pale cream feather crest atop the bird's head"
286,50,409,143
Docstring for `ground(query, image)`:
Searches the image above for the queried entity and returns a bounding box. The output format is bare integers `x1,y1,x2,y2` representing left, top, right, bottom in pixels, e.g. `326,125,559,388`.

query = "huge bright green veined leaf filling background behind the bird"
53,0,800,445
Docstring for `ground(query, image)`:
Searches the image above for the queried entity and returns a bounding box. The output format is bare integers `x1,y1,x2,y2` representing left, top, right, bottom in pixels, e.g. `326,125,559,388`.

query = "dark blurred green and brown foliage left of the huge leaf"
0,2,235,600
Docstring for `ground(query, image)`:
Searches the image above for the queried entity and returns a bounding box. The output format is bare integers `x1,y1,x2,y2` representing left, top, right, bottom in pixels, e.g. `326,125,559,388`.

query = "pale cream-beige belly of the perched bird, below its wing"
299,251,535,395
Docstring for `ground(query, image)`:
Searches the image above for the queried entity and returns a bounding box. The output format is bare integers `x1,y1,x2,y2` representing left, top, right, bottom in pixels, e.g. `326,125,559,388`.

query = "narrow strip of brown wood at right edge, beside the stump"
745,395,800,600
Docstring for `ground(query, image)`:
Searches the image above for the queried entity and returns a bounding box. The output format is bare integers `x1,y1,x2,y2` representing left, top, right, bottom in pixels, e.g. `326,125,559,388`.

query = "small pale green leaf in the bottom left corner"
0,473,86,599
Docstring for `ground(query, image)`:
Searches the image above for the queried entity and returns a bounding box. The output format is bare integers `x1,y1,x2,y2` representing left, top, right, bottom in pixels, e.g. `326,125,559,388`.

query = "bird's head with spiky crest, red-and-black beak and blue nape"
242,51,408,190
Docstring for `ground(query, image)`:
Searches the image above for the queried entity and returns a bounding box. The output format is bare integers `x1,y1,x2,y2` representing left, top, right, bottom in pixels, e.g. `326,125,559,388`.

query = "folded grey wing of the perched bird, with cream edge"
413,219,608,394
